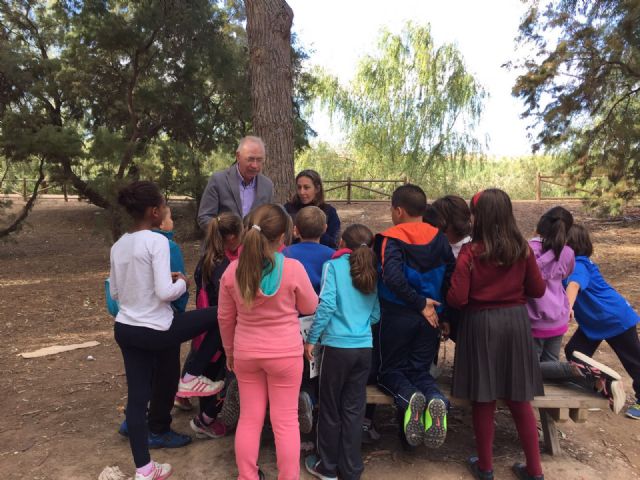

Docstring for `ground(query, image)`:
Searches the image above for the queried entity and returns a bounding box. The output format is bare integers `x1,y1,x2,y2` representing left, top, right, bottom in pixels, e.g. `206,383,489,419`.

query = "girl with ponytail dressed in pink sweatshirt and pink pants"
218,204,318,480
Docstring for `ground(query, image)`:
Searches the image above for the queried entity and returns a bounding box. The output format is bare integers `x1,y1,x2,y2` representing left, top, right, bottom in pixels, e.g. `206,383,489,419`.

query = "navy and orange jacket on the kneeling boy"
374,223,456,312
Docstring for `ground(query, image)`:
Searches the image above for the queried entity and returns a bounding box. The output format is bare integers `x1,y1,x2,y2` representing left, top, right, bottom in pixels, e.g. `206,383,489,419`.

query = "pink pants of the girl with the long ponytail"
234,356,303,480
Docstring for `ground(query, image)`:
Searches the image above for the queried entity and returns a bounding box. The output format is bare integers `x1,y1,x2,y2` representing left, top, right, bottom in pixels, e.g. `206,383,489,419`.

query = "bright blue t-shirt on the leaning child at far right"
564,256,640,340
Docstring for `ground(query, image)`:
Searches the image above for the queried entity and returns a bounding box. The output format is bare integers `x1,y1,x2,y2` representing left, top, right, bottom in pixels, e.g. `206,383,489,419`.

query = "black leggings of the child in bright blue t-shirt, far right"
564,325,640,403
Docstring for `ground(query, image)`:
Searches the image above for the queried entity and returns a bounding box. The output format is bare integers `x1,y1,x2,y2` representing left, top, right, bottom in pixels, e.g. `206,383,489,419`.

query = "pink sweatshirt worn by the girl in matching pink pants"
218,258,318,360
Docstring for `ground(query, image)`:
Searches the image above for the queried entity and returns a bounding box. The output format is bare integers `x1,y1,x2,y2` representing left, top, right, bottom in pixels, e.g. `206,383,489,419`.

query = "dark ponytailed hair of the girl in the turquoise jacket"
342,223,378,295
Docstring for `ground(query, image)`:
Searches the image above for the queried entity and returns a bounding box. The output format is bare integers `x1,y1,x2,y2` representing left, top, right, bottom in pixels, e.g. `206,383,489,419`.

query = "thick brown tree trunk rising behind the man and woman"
245,0,295,202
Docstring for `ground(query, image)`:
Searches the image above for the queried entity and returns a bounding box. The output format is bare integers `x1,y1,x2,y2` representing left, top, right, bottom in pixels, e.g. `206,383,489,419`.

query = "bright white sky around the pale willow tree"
287,0,531,156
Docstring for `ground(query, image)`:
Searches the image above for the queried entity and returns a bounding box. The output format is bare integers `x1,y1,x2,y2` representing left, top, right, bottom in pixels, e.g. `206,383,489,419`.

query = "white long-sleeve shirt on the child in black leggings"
109,230,187,331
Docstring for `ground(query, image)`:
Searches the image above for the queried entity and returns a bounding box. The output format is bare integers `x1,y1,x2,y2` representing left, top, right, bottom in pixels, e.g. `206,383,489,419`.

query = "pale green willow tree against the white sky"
318,23,485,183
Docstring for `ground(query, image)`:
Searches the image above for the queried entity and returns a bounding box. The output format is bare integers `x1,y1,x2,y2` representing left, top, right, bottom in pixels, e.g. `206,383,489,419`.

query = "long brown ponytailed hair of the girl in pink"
236,204,289,307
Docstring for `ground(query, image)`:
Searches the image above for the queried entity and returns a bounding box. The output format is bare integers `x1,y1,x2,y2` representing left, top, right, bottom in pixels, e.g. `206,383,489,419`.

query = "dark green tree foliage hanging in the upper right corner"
513,0,640,209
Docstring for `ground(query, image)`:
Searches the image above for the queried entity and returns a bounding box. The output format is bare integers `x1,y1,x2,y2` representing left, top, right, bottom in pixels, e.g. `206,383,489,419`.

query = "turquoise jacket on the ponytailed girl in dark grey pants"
307,254,380,348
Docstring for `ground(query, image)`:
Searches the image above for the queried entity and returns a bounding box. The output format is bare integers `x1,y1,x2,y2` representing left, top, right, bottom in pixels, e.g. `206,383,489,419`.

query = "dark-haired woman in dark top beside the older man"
284,170,340,249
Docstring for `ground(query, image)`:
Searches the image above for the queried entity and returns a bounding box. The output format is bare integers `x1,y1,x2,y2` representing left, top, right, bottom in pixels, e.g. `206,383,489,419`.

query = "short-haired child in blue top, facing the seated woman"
282,206,335,294
